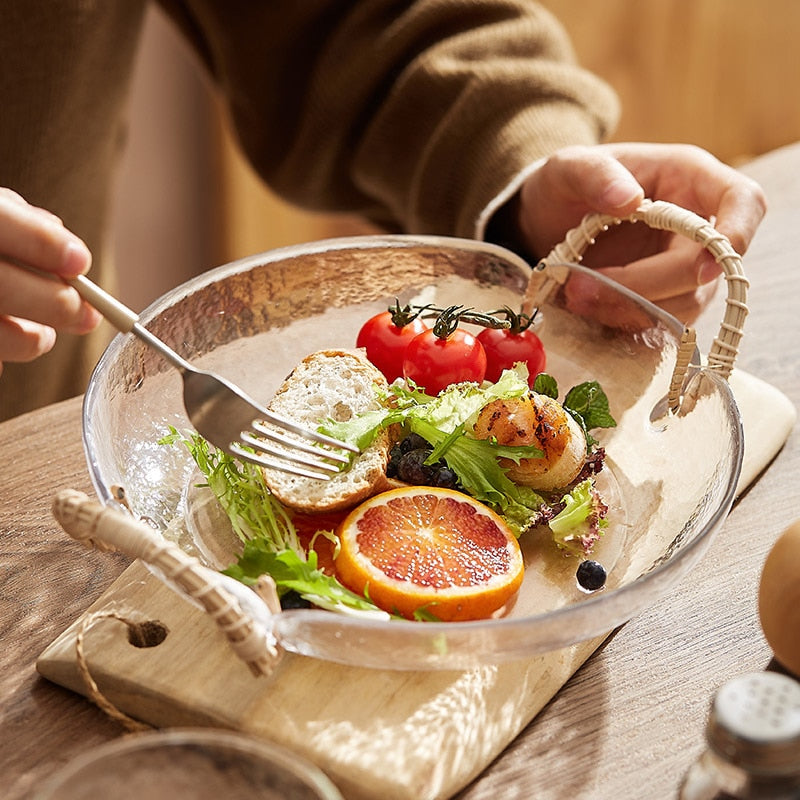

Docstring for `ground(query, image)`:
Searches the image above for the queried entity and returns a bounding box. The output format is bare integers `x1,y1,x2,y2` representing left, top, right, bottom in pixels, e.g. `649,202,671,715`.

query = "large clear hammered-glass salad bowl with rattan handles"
83,236,743,669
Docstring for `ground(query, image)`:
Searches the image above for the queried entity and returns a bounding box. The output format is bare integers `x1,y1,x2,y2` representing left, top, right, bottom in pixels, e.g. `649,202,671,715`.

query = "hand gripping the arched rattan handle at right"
515,143,766,321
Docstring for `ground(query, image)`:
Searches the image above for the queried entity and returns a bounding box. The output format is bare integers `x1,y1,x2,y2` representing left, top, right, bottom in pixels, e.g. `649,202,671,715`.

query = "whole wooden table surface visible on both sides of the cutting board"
0,143,800,800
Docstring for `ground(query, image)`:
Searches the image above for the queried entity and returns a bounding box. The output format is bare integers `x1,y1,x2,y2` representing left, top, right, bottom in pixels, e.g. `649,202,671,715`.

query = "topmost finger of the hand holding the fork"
0,191,91,277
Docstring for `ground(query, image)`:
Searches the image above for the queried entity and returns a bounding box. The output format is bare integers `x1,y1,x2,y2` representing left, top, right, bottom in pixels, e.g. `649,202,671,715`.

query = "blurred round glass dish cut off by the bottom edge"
33,728,343,800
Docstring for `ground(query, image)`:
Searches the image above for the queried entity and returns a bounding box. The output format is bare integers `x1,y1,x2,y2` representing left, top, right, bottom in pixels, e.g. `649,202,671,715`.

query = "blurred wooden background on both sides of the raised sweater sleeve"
112,0,800,305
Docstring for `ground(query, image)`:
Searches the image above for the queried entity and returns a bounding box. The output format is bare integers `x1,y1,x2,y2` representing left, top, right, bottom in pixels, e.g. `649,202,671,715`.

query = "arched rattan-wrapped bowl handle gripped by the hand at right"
523,200,748,396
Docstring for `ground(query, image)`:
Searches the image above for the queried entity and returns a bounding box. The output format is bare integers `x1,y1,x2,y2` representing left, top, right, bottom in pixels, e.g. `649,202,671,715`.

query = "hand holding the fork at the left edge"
0,188,101,372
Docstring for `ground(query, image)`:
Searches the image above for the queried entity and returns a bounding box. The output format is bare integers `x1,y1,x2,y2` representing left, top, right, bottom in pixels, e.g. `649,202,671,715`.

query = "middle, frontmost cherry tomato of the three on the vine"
403,328,486,395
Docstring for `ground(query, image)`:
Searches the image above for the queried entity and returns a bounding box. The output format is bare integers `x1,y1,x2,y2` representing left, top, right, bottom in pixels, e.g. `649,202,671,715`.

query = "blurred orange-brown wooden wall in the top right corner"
544,0,800,163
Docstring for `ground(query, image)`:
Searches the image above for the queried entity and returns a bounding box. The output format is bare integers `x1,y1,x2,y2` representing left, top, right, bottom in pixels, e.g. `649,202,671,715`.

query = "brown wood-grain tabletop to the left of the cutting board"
0,398,127,798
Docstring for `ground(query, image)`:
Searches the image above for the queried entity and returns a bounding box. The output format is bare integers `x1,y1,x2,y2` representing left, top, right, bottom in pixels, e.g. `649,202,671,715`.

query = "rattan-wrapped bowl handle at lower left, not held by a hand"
53,489,279,675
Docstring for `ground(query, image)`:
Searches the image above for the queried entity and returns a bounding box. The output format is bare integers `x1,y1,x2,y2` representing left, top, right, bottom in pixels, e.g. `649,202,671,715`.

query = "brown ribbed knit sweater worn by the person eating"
0,0,617,419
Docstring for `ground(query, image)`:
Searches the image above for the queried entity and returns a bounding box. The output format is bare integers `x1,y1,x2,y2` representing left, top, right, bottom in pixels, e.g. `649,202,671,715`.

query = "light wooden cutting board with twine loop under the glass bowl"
37,372,796,800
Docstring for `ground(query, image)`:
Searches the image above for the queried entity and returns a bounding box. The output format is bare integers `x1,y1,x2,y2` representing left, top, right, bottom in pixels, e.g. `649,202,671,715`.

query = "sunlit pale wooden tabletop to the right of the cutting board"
458,144,800,800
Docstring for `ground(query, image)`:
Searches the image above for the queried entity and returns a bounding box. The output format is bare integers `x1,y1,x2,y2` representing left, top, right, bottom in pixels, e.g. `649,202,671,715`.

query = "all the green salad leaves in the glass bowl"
159,364,616,619
